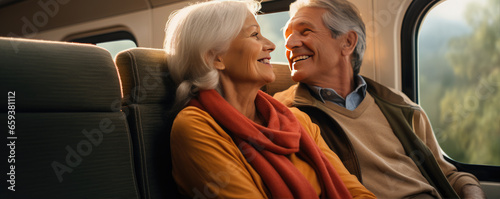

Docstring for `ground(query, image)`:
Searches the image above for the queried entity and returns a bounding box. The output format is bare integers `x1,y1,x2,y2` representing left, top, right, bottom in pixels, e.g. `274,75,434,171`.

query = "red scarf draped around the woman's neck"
189,90,352,199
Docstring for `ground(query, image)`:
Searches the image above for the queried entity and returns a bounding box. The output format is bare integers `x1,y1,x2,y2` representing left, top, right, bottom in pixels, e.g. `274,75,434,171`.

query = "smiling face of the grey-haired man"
285,7,342,85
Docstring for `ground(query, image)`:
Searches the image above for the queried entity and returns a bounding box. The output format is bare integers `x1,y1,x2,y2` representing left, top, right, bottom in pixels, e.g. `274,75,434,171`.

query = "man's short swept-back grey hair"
290,0,366,75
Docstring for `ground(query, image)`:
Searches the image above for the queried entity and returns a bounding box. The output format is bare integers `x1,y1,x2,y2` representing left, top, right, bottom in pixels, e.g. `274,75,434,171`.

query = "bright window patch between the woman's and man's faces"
257,11,290,64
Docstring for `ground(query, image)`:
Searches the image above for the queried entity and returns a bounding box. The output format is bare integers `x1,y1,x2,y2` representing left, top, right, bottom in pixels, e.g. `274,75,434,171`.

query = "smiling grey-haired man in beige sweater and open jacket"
274,0,484,198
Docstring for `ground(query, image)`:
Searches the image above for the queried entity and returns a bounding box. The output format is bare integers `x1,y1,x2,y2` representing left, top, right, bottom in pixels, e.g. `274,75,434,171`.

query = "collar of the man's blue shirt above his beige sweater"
307,75,367,111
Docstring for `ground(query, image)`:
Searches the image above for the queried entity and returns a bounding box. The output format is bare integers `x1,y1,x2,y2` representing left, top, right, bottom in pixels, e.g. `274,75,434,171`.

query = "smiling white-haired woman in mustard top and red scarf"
165,1,374,198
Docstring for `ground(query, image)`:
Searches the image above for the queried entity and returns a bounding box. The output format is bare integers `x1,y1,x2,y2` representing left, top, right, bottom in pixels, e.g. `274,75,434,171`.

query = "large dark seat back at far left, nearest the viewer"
0,38,140,198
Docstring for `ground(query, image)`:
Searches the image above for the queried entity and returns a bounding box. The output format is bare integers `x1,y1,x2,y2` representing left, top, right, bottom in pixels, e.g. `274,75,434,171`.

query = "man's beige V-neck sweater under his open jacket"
319,93,439,198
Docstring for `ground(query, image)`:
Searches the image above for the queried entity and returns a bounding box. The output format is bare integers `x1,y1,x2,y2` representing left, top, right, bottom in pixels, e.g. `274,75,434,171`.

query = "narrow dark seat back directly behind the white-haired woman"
116,48,179,199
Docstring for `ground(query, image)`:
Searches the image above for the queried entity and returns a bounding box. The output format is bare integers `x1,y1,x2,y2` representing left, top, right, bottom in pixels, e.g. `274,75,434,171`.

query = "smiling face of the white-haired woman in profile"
220,12,276,88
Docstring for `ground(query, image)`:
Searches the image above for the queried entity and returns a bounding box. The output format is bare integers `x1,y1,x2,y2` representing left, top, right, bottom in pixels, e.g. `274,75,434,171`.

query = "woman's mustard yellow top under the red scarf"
170,106,375,198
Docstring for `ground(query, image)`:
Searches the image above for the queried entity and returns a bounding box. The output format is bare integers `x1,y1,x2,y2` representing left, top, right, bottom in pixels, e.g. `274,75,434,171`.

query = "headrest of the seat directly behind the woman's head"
116,48,176,106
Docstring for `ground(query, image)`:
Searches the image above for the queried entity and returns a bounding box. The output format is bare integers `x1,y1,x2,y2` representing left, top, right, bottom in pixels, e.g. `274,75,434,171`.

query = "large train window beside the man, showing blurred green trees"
417,0,500,165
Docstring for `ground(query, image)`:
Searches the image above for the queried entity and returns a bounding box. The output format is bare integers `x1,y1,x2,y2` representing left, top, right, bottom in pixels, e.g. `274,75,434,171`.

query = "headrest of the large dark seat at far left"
0,37,121,112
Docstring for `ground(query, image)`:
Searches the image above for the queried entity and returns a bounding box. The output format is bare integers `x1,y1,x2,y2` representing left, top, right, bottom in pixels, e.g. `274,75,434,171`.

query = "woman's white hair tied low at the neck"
164,1,260,108
